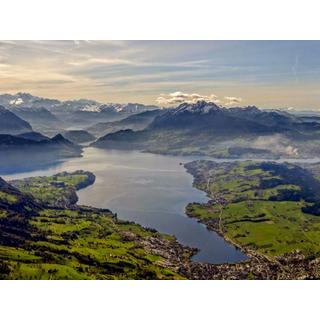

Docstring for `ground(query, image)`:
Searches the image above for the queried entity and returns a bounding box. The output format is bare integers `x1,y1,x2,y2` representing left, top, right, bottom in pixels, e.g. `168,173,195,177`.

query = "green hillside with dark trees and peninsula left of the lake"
0,172,192,279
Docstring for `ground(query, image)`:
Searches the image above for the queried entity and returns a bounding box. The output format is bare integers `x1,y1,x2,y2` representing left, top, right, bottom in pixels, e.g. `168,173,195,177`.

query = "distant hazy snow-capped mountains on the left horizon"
0,92,158,136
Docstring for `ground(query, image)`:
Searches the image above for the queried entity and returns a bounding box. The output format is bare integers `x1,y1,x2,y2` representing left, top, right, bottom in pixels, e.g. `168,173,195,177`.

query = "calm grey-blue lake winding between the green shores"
0,148,250,263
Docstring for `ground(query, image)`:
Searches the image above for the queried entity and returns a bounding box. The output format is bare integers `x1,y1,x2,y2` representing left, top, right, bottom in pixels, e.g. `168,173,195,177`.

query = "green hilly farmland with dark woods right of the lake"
187,161,320,256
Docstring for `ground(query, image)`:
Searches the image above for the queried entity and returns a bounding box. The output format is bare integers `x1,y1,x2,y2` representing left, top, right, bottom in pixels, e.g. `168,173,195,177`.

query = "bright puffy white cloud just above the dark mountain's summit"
156,91,221,105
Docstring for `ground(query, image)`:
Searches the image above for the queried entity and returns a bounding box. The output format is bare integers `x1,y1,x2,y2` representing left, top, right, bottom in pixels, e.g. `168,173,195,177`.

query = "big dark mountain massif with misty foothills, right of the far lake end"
92,101,320,157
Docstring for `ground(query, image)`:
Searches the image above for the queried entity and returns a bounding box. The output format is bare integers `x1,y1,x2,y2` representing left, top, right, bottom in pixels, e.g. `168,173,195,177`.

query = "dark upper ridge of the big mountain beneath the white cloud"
148,101,310,133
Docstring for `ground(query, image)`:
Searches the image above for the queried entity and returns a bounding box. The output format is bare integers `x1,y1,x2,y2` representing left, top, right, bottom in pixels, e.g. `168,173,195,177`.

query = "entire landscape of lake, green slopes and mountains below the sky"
0,93,320,279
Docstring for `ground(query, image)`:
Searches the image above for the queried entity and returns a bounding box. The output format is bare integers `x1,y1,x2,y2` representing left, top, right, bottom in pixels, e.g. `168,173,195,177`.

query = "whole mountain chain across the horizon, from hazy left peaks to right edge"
0,93,320,158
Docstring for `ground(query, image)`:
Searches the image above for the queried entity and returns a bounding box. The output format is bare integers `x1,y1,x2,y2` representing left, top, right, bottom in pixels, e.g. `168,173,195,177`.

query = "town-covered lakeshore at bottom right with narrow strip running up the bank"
185,164,320,280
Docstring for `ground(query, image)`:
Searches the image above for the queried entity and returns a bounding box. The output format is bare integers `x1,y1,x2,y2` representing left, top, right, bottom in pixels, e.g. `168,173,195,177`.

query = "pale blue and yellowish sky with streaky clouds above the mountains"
0,41,320,109
